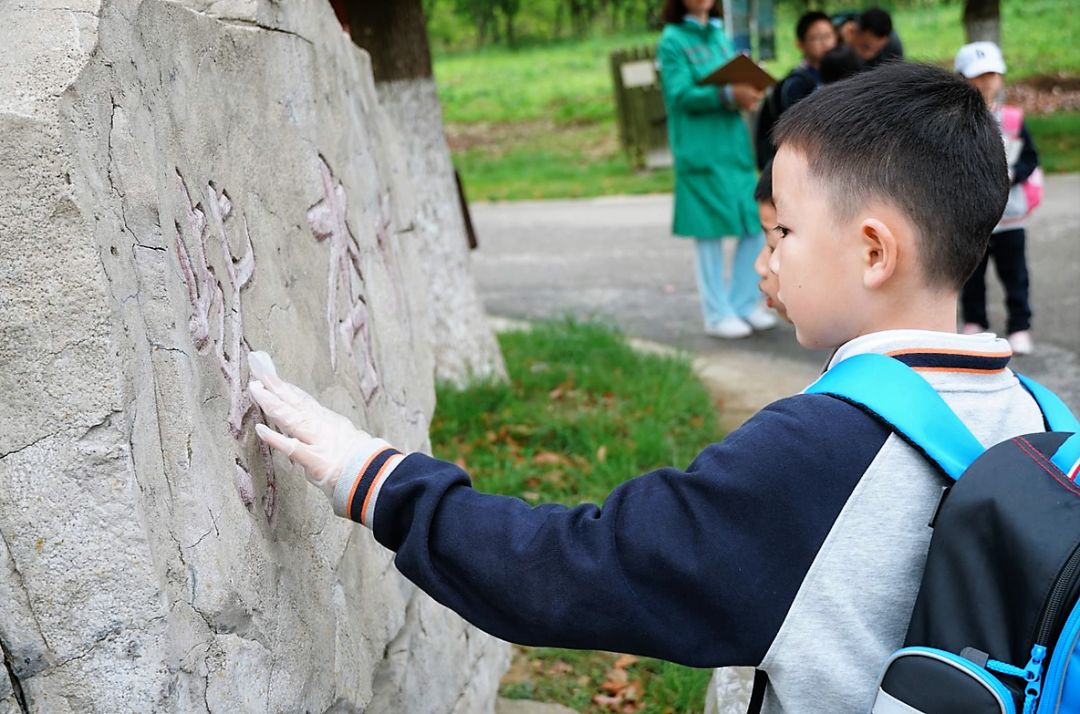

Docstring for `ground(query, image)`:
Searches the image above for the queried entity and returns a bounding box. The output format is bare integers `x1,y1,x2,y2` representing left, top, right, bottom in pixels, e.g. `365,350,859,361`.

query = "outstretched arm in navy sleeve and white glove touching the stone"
253,349,888,666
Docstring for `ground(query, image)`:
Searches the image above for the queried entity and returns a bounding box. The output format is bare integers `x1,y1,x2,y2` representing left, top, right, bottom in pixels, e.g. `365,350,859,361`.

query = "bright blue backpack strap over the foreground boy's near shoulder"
807,354,985,480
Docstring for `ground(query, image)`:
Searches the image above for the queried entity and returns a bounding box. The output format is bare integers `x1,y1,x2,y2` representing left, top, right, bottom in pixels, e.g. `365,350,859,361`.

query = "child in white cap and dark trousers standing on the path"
955,42,1042,354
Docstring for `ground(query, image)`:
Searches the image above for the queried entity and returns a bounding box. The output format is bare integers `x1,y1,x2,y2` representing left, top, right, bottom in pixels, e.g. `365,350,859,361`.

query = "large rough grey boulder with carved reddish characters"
0,0,509,713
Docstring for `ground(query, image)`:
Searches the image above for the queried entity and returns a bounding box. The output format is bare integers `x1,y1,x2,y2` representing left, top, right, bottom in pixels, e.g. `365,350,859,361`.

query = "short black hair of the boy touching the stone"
773,63,1009,288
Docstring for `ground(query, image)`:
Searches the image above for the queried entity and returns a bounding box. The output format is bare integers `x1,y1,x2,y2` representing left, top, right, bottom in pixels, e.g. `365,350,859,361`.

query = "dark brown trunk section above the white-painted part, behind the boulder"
343,0,432,82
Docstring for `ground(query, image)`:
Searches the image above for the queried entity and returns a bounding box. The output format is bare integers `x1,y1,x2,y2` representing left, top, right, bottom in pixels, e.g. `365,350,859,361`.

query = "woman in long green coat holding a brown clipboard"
657,0,777,338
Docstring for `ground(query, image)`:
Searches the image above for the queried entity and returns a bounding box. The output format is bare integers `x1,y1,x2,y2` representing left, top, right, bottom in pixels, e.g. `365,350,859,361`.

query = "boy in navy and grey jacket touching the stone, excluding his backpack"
251,64,1042,714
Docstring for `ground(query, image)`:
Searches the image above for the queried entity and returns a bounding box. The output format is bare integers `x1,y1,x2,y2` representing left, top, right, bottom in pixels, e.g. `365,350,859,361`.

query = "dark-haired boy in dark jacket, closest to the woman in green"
754,10,836,170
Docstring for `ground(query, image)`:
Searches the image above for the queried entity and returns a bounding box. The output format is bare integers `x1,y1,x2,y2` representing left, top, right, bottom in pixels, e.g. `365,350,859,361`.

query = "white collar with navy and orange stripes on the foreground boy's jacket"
826,329,1012,375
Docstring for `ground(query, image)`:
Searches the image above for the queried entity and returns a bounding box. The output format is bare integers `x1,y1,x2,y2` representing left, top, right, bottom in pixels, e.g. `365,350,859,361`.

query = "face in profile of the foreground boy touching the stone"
768,146,864,349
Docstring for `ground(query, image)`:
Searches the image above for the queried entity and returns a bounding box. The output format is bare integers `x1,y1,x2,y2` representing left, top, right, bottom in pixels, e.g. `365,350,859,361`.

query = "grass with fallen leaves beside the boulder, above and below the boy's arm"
431,321,720,714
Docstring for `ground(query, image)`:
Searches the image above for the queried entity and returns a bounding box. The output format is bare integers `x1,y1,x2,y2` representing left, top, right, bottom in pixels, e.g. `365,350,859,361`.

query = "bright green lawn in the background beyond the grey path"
435,0,1080,200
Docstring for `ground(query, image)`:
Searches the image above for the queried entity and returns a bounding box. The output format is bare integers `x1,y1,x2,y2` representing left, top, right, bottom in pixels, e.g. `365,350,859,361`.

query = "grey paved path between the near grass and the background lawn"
472,174,1080,428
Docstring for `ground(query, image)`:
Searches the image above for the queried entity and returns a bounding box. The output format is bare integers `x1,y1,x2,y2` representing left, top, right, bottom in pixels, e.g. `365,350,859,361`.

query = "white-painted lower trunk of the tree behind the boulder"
376,78,505,385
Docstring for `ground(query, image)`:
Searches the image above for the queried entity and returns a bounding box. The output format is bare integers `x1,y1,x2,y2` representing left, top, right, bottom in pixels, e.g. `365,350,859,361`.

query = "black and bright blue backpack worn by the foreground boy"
807,354,1080,714
